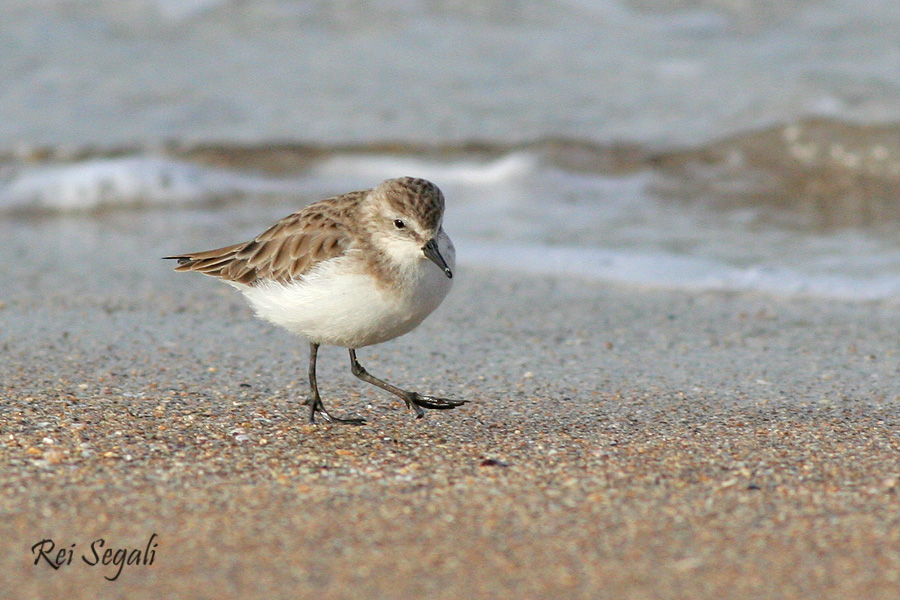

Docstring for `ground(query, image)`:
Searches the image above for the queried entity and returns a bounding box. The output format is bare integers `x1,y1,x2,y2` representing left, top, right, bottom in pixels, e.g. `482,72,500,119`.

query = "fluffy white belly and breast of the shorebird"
240,251,451,348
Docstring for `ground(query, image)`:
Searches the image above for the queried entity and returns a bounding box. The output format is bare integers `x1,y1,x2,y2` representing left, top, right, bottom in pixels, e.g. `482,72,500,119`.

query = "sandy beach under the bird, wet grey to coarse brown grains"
0,221,900,599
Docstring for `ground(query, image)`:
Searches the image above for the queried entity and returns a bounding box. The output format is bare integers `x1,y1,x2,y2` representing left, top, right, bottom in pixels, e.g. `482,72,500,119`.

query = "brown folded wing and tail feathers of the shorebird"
166,192,365,285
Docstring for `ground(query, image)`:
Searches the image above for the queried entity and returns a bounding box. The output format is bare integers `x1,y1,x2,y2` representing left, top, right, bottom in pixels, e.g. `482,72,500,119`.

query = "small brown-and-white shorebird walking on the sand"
164,177,466,425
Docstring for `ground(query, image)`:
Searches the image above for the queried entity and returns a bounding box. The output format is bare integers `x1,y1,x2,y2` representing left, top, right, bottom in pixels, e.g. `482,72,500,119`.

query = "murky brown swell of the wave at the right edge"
651,118,900,229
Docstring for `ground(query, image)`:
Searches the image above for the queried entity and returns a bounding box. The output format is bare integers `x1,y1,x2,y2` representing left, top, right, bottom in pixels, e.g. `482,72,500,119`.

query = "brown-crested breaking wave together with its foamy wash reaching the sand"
0,119,900,300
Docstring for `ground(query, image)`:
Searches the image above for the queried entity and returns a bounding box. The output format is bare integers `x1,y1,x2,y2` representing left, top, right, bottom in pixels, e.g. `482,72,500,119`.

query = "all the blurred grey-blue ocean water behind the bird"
0,0,900,300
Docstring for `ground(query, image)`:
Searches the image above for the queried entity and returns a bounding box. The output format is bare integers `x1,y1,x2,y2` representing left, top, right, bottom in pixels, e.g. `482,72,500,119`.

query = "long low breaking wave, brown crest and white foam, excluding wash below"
0,118,900,230
